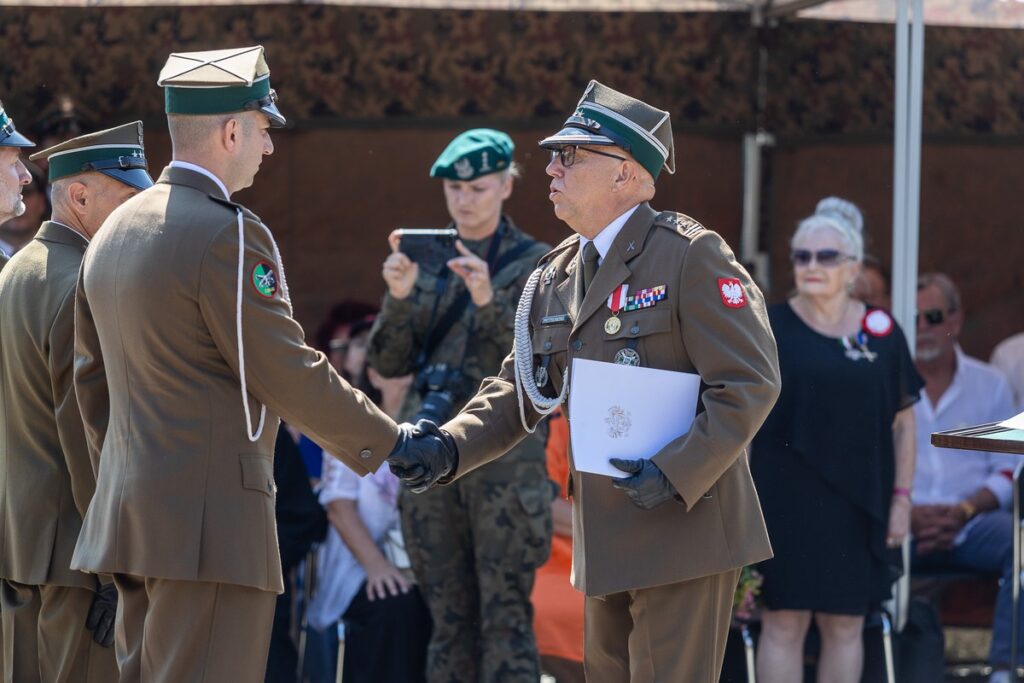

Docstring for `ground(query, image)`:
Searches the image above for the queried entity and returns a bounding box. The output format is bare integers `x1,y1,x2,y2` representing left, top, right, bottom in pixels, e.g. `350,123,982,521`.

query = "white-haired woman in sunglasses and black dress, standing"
751,198,922,683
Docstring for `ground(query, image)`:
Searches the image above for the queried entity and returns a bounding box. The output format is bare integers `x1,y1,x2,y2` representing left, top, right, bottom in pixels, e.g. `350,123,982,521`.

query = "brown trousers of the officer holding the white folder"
584,569,739,683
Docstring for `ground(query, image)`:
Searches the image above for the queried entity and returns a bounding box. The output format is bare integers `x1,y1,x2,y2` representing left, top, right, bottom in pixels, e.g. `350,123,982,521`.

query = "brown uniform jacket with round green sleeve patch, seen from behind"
73,168,398,592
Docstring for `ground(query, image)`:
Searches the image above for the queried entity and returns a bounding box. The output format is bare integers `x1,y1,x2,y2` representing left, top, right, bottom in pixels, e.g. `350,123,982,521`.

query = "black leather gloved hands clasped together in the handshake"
387,420,459,494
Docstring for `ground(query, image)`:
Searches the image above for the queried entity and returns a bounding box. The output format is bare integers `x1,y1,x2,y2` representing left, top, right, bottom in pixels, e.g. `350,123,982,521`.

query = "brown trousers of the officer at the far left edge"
0,580,118,683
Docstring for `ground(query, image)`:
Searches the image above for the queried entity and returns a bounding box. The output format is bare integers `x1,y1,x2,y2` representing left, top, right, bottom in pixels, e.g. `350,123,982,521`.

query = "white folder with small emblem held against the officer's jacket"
569,358,700,477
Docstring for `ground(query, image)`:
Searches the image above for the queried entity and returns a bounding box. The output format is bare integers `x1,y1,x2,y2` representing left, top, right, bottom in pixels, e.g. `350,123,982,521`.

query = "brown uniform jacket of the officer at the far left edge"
0,221,96,588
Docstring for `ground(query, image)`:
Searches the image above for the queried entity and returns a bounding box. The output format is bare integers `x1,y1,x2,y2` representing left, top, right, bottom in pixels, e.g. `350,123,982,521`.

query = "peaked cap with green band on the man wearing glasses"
541,81,676,178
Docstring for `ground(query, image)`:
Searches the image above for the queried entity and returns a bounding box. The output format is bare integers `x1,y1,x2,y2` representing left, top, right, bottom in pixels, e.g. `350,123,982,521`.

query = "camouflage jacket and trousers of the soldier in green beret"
369,217,554,683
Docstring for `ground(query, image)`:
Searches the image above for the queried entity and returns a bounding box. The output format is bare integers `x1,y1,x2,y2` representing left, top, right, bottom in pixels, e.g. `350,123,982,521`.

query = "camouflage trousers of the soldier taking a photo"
399,452,554,683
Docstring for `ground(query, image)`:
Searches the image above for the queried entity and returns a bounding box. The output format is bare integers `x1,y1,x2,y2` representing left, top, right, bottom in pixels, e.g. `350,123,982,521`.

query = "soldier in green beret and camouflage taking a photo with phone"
370,129,553,683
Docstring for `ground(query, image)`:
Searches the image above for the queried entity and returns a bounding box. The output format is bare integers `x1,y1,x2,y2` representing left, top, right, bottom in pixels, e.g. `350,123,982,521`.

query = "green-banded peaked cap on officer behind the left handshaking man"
29,121,153,189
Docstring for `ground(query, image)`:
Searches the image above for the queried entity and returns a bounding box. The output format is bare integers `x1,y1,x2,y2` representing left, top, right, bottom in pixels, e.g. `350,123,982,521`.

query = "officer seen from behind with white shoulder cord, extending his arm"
72,46,398,683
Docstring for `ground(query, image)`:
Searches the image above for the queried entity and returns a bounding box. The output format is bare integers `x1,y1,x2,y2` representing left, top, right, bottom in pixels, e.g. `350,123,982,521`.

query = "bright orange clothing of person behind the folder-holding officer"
530,411,584,661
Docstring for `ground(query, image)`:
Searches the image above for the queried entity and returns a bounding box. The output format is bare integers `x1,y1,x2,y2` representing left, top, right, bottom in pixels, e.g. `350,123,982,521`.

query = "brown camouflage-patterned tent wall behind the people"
0,5,1024,357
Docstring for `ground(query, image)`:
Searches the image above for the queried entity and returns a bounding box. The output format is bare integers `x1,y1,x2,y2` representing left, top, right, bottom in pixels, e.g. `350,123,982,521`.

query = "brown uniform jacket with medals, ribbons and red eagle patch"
444,204,779,595
